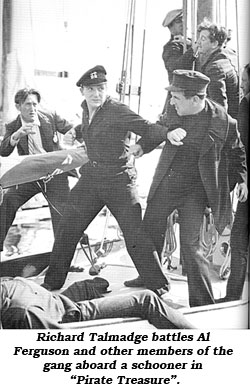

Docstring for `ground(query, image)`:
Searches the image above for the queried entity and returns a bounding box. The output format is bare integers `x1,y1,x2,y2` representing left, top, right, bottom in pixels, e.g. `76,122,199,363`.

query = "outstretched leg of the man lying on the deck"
78,290,194,329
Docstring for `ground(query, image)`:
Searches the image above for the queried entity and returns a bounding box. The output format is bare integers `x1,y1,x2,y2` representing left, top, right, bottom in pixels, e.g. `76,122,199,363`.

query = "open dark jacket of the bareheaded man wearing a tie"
0,111,72,157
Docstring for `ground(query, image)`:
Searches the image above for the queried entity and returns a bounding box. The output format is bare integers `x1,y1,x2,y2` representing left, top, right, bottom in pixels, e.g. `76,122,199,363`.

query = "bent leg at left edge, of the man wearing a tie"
0,182,40,251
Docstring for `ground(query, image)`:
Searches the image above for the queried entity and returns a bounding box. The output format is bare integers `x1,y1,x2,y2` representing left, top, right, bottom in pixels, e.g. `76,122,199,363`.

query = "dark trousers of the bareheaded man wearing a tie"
0,174,69,251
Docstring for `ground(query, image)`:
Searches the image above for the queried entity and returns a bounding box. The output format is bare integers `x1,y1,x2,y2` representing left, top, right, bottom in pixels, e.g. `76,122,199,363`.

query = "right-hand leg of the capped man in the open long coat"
178,188,214,307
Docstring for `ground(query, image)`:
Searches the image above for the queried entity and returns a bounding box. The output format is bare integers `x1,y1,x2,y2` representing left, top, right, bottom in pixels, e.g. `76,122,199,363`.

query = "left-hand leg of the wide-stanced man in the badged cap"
44,176,103,290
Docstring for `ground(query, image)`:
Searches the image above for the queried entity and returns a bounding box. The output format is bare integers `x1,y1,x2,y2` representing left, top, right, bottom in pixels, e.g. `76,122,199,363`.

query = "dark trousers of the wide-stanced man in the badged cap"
45,166,170,290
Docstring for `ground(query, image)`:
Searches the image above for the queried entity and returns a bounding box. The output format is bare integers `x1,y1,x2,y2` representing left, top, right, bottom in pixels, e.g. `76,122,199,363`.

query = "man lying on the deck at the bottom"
0,277,194,329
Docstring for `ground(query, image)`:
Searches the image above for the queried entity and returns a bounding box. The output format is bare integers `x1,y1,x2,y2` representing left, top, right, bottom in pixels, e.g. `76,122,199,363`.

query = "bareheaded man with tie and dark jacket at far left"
0,88,72,251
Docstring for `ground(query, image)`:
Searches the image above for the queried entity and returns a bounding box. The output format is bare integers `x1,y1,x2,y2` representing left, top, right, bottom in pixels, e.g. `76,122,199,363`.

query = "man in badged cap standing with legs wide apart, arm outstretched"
42,65,172,295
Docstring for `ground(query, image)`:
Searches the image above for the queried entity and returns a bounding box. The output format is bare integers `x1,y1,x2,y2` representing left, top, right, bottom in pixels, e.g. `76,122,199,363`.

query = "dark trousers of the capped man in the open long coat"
133,175,214,306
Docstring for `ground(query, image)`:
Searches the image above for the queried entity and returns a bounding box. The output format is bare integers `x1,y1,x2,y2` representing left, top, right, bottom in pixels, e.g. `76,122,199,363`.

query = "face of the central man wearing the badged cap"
81,83,107,110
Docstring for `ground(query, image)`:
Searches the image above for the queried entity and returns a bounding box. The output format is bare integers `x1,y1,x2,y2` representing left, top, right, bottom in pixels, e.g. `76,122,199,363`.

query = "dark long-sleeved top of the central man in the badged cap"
78,97,167,175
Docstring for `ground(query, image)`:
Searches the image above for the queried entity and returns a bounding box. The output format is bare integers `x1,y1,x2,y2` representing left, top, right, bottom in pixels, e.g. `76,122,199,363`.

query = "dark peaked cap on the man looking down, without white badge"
166,70,210,94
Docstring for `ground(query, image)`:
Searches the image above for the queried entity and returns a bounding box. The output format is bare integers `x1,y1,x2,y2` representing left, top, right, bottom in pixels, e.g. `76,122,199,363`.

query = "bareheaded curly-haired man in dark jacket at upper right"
175,21,239,119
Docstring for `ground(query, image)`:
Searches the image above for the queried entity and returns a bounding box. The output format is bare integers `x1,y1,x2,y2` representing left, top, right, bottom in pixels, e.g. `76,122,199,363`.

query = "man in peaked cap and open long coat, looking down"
129,70,247,306
